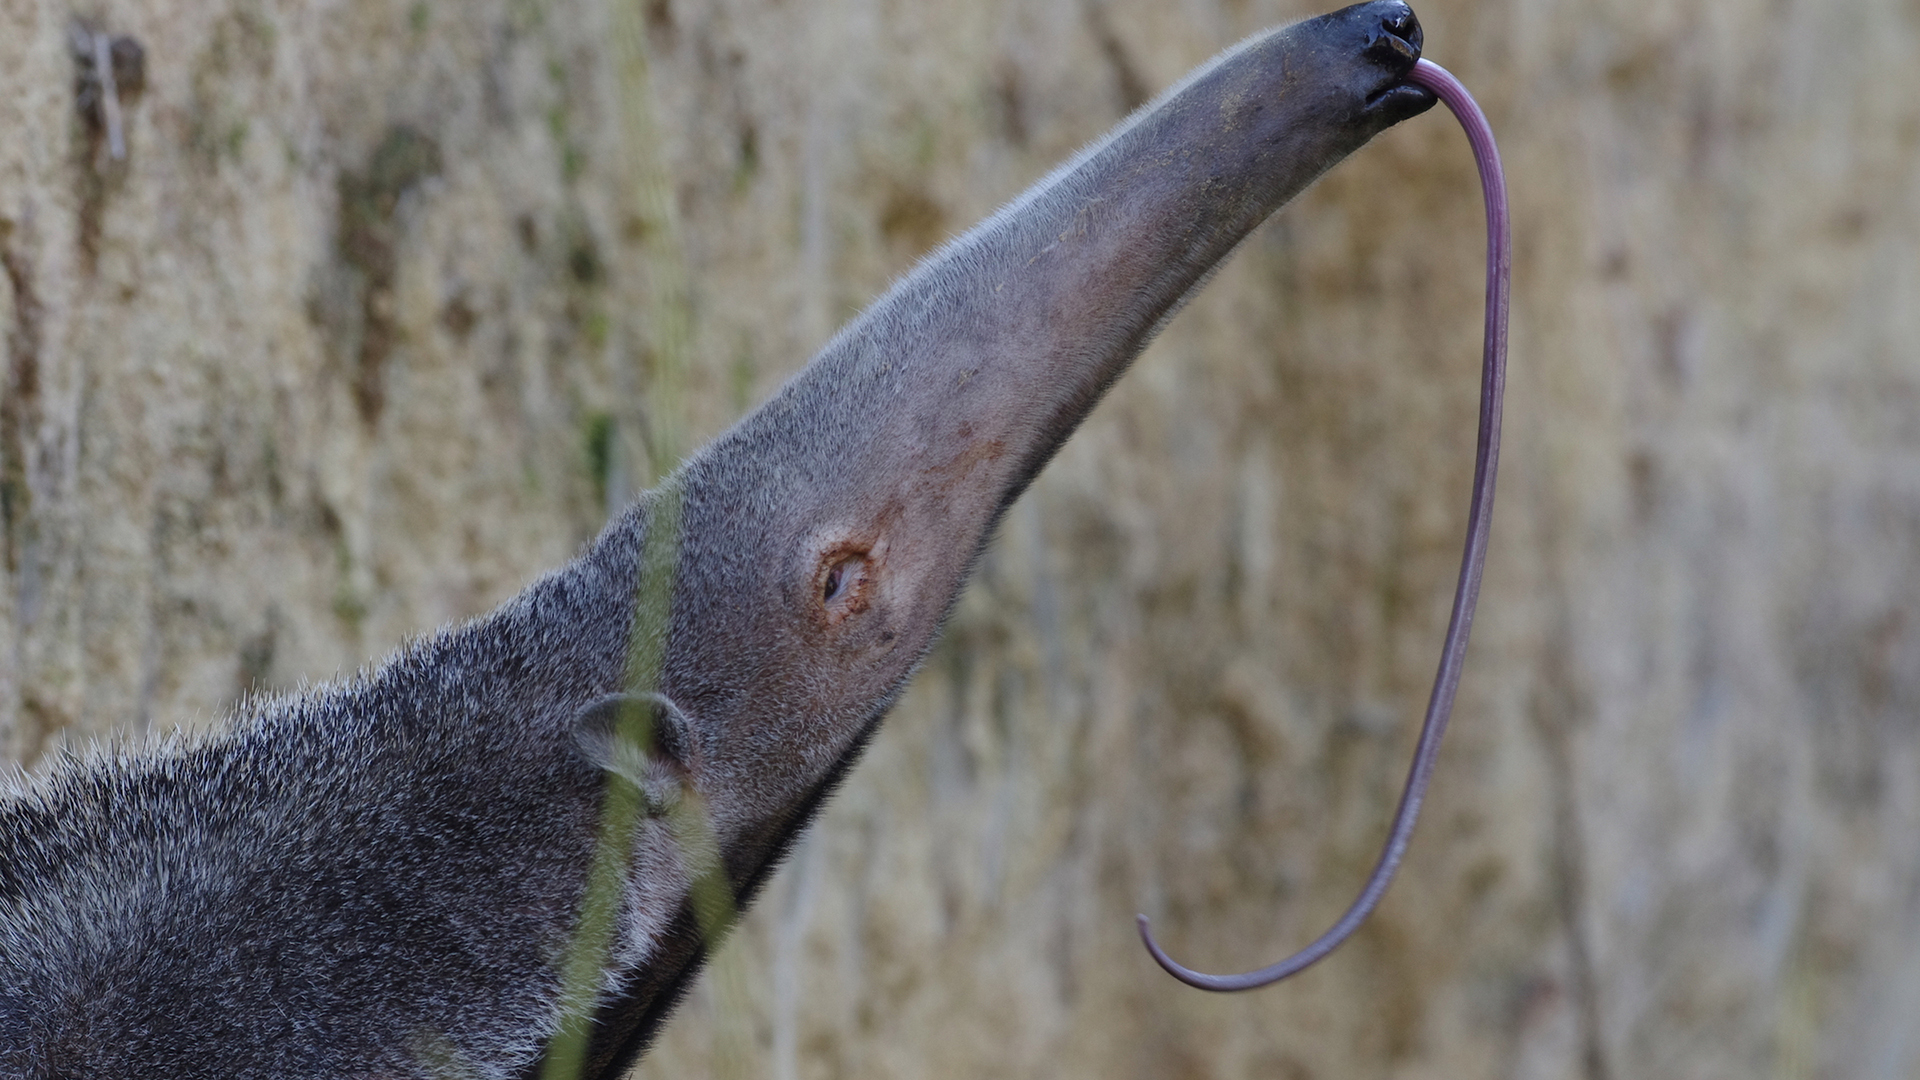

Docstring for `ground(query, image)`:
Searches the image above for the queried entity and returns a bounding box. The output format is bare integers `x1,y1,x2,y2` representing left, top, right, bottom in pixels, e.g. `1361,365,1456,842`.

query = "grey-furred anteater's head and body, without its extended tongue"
0,2,1432,1080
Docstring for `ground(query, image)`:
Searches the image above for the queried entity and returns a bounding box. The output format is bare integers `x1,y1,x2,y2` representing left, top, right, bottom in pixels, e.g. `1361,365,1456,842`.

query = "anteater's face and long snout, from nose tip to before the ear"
668,0,1434,814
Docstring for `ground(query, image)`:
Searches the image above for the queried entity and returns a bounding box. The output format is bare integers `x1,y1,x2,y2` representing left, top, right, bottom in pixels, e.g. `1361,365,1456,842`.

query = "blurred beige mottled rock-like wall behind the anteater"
0,0,1920,1080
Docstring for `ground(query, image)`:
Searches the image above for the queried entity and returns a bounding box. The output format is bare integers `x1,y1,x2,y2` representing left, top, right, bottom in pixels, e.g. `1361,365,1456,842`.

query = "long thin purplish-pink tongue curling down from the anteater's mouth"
1139,60,1513,990
